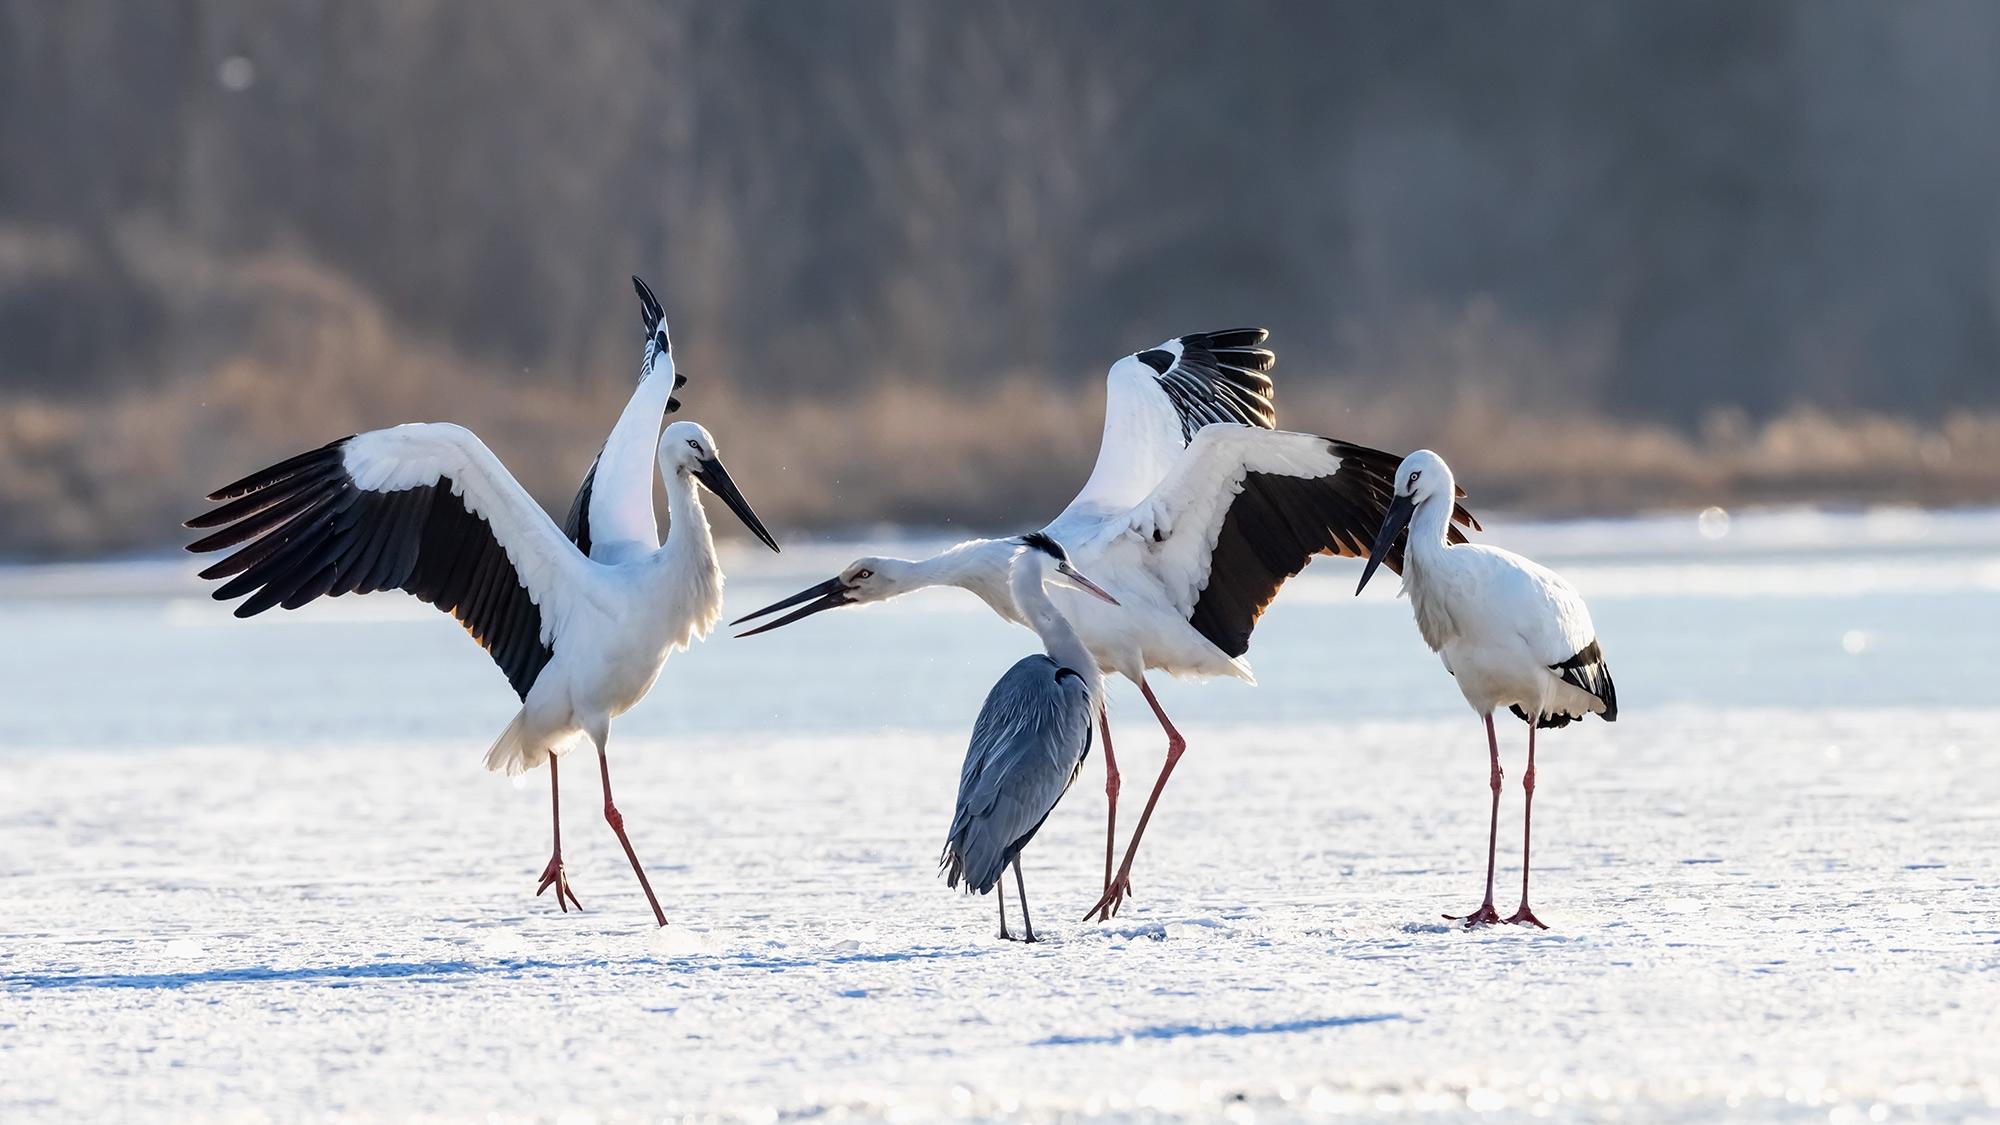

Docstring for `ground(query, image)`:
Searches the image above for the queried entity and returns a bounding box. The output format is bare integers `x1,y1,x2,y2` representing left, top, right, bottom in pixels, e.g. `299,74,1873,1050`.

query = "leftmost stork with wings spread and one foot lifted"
188,300,778,927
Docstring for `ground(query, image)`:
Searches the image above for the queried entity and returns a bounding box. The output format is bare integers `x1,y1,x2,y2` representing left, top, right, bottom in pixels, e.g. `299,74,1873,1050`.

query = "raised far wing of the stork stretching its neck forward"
1056,328,1278,520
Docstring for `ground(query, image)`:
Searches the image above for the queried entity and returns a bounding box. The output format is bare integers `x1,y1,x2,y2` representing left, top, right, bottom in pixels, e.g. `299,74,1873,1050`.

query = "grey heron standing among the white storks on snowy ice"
938,532,1118,941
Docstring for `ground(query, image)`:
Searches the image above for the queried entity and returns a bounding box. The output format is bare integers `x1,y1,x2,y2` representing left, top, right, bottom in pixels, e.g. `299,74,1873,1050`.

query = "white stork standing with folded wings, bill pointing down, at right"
1354,448,1618,929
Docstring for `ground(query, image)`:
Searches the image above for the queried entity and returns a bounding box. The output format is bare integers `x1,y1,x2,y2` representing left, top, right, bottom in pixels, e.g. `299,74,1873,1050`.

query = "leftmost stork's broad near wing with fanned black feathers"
188,422,598,697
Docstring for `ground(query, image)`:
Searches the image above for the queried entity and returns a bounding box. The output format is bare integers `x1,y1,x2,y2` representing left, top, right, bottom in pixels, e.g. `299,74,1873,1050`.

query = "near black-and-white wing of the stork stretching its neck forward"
1122,426,1478,657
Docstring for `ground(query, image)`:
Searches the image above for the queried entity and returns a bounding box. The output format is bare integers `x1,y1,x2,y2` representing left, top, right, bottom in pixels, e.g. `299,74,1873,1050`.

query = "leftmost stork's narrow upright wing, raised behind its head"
562,278,688,556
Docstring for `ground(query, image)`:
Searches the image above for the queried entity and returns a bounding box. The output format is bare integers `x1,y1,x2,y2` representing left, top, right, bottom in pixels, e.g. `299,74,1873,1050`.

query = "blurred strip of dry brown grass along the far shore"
0,230,2000,556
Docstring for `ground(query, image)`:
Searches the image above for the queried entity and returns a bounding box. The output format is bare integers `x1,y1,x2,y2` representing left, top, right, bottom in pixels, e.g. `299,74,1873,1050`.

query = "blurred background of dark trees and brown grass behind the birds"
0,0,2000,558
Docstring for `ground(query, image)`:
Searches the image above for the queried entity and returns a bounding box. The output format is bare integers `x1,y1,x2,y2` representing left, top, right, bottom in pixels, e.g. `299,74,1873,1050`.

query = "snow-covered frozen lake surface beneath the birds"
0,512,2000,1121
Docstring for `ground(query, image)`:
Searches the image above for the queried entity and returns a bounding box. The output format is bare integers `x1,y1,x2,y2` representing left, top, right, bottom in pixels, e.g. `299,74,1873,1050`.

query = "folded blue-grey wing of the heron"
944,655,1092,893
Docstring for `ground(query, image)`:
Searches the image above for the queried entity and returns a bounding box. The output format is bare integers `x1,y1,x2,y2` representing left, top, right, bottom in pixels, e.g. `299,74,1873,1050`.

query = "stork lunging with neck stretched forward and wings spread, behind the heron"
734,328,1478,919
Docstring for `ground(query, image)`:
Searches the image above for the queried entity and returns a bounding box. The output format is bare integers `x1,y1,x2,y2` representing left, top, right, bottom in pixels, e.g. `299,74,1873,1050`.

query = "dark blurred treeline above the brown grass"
11,0,2000,422
